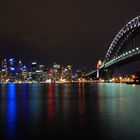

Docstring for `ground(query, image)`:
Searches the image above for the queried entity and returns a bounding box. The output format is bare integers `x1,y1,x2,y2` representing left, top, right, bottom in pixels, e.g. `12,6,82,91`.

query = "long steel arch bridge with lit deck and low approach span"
86,16,140,76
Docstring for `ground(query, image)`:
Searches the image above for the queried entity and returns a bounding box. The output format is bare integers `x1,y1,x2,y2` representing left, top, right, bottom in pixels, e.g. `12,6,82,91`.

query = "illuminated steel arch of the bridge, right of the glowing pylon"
103,16,140,67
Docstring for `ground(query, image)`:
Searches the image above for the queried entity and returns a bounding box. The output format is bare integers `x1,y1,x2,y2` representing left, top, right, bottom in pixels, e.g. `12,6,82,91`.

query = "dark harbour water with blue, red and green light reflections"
0,83,140,140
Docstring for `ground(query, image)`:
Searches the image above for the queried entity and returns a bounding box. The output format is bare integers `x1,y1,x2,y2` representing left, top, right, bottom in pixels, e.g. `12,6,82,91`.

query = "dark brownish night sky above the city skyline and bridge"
0,0,140,69
